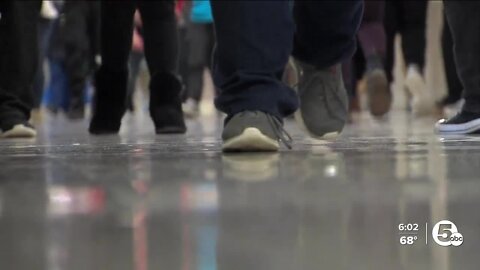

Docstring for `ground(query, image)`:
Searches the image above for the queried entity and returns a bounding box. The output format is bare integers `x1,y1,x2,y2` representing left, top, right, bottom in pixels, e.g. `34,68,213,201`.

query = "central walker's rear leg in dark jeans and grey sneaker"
293,1,363,139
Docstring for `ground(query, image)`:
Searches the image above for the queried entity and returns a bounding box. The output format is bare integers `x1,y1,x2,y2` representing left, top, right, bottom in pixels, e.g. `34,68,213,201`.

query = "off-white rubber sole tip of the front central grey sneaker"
222,127,280,152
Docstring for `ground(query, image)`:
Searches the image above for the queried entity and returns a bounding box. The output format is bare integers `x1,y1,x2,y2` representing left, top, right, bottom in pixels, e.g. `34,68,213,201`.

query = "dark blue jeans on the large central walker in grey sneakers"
212,0,363,118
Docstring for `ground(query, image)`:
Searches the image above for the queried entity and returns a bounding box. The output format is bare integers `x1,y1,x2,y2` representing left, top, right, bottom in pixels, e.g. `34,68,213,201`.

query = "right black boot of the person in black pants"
150,72,187,134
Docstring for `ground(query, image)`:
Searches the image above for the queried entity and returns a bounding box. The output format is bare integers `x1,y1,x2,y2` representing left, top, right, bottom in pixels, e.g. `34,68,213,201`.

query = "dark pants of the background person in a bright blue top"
186,22,215,102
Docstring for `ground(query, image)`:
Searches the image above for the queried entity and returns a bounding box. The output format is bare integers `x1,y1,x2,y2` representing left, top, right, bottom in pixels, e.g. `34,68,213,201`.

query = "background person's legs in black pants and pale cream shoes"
385,0,433,115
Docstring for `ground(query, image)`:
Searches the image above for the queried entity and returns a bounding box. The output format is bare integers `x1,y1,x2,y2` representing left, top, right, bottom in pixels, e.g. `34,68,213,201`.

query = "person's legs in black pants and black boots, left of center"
89,0,186,134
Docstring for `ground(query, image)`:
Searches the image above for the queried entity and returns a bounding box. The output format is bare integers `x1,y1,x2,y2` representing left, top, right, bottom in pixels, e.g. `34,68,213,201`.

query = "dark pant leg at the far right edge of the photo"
445,0,480,113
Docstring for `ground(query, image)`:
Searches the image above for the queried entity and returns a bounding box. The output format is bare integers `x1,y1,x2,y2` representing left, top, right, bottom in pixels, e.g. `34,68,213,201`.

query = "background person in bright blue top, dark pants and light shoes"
183,0,215,117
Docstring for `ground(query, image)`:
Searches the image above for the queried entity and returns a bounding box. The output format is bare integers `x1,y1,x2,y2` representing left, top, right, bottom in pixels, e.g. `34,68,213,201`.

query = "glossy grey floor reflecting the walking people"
0,112,480,270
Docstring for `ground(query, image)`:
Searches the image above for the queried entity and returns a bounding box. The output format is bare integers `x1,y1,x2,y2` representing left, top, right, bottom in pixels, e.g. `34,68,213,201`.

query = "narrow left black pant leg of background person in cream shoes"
383,1,400,82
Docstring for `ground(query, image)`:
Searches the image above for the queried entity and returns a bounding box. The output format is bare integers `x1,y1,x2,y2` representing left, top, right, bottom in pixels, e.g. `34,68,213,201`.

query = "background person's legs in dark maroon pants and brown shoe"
344,1,392,116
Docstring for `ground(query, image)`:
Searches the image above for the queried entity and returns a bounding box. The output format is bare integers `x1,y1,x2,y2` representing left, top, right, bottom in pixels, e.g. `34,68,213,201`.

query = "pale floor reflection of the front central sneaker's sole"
222,153,280,182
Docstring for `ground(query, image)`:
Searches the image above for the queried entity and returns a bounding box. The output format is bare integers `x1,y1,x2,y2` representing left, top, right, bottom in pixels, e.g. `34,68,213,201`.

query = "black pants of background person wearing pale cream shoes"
385,0,428,81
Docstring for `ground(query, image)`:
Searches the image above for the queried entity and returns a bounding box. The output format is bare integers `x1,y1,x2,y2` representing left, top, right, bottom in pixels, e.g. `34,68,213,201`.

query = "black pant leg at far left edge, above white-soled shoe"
0,0,41,128
